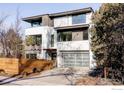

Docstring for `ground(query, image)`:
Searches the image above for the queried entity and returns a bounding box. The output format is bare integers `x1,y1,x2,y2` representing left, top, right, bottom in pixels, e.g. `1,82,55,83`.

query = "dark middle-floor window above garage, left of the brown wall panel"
58,31,72,41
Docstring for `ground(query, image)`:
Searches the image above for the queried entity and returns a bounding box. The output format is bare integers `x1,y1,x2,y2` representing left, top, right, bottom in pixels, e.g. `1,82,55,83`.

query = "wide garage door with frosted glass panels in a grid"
61,51,89,67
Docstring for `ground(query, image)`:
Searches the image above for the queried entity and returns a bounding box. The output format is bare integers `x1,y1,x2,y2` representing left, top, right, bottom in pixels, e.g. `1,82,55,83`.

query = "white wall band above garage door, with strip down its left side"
57,40,89,67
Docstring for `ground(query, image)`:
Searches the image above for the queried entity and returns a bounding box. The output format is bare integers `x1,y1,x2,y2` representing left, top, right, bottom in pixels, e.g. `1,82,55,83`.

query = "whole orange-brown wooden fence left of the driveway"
0,58,55,75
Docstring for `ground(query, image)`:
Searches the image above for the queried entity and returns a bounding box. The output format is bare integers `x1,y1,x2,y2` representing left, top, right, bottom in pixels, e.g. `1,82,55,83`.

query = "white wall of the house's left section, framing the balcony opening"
25,26,57,59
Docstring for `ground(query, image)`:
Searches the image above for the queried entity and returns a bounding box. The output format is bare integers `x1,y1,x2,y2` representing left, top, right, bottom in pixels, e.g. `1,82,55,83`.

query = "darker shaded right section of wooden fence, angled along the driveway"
20,60,54,76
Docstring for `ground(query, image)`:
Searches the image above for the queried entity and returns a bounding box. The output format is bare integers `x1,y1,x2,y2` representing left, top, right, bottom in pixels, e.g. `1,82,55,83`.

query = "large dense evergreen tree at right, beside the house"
91,3,124,82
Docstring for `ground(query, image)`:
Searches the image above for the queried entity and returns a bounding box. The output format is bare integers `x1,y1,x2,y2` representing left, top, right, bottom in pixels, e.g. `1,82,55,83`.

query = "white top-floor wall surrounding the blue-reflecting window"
54,13,92,27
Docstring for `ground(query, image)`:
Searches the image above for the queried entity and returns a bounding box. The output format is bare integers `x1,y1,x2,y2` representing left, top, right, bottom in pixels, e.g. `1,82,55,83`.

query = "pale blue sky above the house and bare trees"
0,3,101,28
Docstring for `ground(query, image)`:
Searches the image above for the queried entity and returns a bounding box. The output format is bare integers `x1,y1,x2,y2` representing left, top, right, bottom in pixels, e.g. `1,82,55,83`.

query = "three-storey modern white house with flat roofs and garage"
23,7,93,67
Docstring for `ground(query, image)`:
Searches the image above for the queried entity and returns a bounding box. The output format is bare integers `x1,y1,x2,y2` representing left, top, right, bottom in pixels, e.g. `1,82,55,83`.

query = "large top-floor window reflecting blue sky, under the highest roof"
72,14,86,24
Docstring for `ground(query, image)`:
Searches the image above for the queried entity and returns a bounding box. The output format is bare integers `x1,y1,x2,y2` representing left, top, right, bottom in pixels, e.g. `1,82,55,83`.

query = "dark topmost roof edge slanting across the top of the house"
22,7,93,22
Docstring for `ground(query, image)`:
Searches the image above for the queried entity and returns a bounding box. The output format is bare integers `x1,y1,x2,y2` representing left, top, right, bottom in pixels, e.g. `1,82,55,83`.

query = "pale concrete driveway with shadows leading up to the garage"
0,68,89,86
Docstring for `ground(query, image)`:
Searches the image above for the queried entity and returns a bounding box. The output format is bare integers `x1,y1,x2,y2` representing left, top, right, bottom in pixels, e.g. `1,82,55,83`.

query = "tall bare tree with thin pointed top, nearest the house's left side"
7,8,22,57
